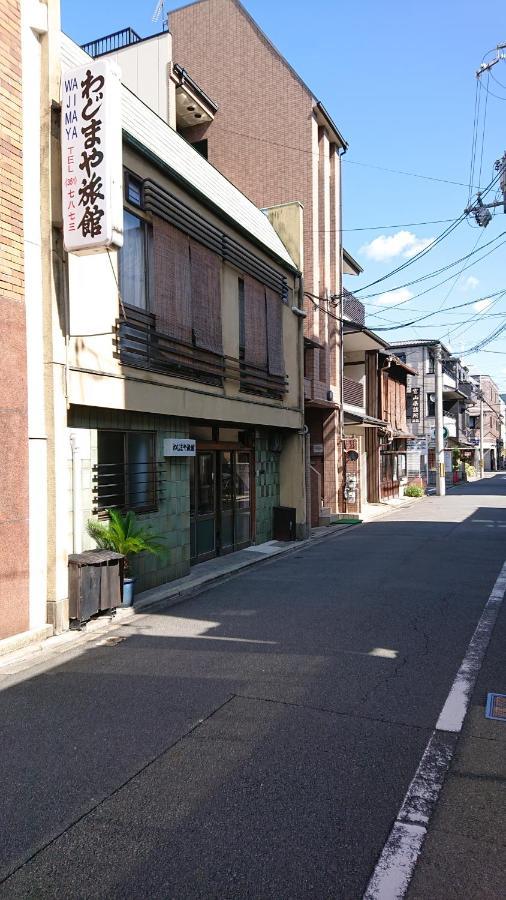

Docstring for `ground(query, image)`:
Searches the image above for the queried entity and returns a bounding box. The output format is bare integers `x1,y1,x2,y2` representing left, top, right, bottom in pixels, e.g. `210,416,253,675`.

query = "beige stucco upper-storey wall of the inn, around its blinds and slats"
68,142,302,428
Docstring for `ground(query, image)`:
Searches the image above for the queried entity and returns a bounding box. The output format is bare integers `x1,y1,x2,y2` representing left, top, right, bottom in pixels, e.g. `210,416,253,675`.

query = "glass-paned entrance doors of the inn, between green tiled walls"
190,450,251,563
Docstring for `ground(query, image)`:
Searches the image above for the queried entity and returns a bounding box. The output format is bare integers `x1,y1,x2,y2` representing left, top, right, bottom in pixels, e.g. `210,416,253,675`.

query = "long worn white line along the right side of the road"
363,562,506,900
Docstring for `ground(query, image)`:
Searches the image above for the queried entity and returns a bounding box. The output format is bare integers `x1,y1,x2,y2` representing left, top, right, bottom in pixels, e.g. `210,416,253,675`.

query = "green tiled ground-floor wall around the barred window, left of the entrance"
69,407,190,592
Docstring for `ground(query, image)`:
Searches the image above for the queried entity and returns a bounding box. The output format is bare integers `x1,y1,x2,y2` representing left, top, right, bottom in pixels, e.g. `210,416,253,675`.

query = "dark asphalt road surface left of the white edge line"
0,474,506,900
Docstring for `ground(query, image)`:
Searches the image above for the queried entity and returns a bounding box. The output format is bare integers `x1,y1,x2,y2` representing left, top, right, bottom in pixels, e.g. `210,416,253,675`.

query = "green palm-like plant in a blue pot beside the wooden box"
86,509,165,606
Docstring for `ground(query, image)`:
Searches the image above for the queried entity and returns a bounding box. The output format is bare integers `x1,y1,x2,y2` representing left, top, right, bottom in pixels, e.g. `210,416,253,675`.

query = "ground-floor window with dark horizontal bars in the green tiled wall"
96,431,156,512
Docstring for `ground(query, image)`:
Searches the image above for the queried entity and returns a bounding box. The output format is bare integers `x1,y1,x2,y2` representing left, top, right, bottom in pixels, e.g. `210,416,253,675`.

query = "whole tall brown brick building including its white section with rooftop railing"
89,0,362,528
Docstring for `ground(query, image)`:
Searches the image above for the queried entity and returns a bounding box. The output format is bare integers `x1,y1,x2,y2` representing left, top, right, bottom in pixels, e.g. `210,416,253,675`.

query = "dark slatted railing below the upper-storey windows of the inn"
115,307,288,399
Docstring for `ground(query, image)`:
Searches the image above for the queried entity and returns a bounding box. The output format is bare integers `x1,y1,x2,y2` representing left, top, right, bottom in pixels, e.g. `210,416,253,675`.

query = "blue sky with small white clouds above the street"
62,0,506,392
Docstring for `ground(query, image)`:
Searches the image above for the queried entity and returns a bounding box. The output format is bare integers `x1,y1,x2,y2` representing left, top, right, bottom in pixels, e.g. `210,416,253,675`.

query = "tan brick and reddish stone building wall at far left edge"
0,0,29,639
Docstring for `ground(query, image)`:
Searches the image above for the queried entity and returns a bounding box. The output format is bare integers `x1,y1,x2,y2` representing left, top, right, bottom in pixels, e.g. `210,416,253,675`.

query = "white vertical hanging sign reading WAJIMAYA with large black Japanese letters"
61,59,123,254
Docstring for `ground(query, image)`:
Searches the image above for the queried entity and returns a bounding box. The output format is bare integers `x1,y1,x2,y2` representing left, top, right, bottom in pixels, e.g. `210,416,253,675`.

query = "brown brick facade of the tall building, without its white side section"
169,0,354,520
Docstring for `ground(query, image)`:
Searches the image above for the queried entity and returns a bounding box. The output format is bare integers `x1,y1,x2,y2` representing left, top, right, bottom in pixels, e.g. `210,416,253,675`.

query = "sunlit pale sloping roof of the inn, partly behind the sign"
61,34,297,270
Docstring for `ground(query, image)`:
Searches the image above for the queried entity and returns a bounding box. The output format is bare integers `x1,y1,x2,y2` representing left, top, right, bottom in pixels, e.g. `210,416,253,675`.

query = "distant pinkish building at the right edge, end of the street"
469,375,504,472
